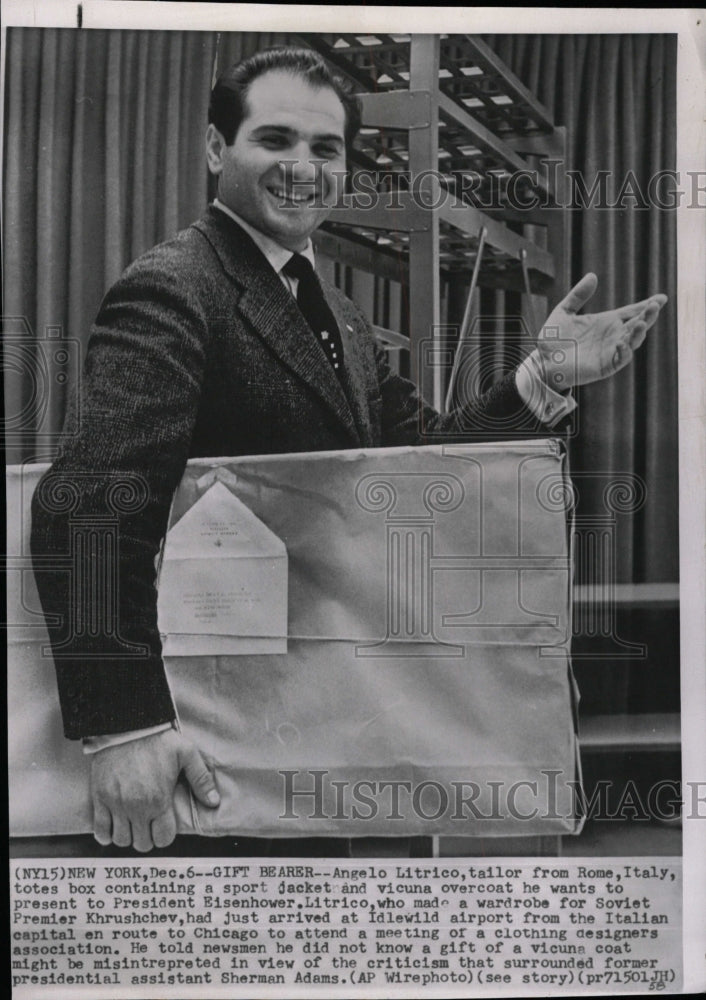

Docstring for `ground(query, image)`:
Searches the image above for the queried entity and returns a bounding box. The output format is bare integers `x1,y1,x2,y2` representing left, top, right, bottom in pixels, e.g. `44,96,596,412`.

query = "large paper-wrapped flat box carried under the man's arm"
8,440,580,837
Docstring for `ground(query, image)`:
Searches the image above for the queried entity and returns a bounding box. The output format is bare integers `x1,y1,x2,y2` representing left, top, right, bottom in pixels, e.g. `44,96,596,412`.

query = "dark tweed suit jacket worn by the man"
31,207,527,738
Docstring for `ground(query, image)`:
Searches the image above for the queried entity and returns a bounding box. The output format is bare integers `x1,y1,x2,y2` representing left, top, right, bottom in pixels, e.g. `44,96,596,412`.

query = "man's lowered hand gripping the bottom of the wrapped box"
91,729,220,851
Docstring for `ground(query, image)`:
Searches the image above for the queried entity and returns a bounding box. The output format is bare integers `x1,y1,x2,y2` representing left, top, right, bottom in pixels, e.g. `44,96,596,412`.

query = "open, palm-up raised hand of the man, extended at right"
532,274,667,392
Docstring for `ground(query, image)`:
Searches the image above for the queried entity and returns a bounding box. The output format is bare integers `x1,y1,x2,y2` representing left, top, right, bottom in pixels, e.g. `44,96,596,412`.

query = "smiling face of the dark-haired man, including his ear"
206,70,346,251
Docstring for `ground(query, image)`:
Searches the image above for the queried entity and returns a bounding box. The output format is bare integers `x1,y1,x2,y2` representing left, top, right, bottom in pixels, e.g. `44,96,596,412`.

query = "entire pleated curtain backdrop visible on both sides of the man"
3,28,678,581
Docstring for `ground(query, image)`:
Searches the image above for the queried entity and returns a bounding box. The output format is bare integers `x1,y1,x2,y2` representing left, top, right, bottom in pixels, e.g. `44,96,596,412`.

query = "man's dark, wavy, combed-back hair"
208,46,360,154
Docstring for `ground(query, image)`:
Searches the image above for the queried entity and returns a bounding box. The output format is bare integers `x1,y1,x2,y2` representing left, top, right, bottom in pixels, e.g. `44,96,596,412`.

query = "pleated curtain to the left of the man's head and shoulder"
3,28,284,462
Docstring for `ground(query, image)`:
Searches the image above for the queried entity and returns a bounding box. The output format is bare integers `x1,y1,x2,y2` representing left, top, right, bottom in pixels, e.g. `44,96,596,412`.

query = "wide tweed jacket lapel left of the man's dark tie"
194,207,360,444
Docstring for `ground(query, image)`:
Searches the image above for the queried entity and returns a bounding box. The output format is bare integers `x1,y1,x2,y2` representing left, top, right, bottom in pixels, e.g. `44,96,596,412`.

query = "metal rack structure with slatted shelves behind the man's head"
301,34,568,408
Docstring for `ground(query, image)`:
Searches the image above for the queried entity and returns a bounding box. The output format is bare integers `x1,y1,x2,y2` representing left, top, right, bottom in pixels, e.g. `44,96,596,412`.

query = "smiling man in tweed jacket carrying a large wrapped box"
32,49,664,851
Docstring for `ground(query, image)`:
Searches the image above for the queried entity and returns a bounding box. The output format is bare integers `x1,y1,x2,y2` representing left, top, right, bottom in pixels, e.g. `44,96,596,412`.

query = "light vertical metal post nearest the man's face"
409,35,443,410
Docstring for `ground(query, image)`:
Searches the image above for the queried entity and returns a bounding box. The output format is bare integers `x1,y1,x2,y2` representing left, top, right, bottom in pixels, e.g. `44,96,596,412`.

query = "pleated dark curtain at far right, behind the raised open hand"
483,35,679,582
